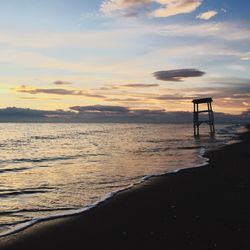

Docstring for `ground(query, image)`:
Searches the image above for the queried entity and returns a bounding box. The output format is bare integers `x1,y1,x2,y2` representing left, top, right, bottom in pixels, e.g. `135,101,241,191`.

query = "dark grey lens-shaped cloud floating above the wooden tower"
153,69,205,82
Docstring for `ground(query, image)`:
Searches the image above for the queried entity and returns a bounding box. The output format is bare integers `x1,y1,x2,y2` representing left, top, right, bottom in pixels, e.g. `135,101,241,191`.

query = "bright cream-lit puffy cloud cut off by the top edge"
100,0,202,17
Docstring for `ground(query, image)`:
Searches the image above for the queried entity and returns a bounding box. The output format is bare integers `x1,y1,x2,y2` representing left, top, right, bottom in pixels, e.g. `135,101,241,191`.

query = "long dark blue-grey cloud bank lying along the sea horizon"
0,105,250,126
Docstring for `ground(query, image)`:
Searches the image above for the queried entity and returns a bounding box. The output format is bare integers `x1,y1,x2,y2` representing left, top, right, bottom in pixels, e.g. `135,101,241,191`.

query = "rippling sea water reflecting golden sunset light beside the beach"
0,124,243,236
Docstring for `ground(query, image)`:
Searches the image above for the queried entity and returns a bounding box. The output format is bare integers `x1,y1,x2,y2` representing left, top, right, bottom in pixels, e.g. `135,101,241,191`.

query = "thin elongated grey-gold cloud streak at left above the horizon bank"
14,85,106,99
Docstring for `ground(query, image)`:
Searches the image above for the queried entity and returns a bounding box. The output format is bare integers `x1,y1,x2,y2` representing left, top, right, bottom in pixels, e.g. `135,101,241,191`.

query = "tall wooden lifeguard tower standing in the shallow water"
193,97,215,136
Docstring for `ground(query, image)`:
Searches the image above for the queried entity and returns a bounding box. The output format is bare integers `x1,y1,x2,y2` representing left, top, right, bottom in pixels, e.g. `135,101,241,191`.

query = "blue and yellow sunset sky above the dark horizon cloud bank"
0,0,250,115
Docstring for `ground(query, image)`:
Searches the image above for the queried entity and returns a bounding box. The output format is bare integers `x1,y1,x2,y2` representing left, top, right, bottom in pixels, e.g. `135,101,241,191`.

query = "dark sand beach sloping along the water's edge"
0,126,250,250
